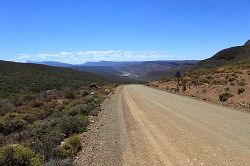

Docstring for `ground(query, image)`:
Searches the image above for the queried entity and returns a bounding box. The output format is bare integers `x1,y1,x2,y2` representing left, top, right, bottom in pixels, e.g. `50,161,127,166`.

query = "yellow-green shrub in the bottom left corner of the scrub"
0,144,42,166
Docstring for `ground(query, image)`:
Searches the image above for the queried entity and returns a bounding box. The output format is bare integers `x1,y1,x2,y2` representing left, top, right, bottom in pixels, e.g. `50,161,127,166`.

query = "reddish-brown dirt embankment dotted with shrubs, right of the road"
148,69,250,112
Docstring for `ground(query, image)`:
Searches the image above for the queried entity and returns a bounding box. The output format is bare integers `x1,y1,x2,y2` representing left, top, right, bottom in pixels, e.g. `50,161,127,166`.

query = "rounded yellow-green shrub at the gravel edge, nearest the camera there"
55,136,82,157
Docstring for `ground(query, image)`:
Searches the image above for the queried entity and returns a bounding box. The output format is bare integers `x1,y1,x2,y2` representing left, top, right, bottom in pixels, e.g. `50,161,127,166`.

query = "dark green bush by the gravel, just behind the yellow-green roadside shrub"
58,116,88,136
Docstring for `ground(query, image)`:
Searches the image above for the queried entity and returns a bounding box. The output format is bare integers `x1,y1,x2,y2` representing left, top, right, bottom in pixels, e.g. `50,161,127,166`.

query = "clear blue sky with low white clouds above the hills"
0,0,250,63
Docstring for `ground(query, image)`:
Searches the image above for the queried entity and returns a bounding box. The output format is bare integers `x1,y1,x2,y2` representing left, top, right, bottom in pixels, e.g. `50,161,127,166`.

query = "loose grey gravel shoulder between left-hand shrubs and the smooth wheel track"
74,86,123,166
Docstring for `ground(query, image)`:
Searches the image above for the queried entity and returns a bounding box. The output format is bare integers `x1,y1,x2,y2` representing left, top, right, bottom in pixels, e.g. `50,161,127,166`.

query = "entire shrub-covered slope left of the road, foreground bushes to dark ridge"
0,61,115,165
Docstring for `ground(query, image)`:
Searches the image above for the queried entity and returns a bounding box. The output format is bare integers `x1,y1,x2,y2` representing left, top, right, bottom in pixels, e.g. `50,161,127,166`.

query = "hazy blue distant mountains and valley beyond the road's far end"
27,60,198,81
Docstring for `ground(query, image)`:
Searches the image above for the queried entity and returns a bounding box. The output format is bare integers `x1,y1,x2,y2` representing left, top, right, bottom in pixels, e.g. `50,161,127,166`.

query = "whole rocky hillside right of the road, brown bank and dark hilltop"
149,41,250,111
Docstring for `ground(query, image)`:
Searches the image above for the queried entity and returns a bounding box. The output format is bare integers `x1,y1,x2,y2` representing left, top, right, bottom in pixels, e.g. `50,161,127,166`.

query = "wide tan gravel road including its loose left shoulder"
76,85,250,166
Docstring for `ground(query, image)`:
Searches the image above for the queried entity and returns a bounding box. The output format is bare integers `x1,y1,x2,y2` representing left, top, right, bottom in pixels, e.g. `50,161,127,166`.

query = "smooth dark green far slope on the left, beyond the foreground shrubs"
0,61,108,97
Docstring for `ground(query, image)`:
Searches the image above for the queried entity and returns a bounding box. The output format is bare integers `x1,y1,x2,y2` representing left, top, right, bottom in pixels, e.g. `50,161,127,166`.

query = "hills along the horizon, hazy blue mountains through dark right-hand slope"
27,40,250,81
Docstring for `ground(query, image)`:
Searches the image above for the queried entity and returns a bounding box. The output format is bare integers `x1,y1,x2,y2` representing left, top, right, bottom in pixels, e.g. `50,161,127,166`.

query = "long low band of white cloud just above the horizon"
16,50,172,64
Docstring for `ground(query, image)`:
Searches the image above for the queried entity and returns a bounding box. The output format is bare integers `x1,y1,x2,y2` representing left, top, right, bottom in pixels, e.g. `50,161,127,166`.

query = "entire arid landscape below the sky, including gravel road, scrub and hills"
0,42,250,166
